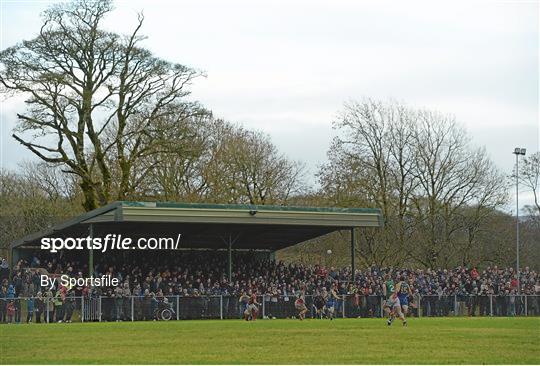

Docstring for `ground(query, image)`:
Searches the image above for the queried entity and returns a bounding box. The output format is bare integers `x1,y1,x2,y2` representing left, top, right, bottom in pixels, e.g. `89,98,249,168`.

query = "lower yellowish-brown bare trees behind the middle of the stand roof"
124,118,303,204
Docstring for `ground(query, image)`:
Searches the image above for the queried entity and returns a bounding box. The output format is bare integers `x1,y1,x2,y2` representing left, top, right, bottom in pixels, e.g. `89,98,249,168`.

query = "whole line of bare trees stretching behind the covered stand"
0,0,540,268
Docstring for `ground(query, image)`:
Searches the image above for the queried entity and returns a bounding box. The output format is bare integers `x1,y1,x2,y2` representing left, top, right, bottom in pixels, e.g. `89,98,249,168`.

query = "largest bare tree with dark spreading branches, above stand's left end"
0,0,200,210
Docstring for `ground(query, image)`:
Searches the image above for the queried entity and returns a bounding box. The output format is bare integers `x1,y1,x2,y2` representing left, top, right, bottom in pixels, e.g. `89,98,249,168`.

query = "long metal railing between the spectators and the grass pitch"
0,294,540,323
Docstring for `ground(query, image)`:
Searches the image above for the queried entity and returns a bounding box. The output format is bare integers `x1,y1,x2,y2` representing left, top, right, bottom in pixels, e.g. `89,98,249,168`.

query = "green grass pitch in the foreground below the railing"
0,317,540,364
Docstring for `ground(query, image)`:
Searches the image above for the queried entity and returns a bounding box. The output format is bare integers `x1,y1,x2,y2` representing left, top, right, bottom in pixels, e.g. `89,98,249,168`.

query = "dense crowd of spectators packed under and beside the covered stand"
0,251,540,322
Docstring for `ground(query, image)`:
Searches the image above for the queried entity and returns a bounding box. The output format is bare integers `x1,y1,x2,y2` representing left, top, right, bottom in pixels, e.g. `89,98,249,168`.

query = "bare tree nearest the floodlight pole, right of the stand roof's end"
412,111,506,266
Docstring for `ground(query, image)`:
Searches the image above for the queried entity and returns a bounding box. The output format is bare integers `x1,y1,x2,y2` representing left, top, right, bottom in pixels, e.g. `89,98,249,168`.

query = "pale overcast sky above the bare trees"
0,0,540,210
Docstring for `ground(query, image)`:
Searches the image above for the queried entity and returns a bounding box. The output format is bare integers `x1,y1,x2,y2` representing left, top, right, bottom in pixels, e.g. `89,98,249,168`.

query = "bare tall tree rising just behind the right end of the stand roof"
318,99,418,264
